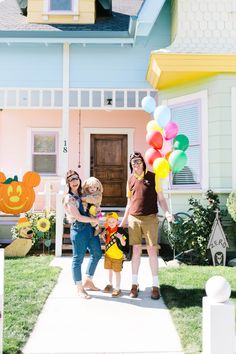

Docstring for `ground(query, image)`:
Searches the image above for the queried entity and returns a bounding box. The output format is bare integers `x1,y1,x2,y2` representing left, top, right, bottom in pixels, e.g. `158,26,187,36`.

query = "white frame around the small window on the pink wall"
27,128,62,179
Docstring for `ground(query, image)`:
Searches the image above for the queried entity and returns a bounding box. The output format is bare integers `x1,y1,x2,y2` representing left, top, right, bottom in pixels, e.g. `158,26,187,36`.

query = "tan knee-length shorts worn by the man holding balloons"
128,214,158,246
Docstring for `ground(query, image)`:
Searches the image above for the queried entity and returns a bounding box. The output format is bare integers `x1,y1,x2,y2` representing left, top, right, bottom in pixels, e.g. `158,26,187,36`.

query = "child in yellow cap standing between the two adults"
100,212,127,297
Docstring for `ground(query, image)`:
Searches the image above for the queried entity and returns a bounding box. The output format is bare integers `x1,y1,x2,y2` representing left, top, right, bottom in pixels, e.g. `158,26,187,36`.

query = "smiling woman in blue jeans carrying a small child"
63,170,102,299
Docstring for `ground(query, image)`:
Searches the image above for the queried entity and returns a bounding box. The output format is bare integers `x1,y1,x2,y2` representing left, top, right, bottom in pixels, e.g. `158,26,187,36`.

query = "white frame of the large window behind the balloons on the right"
161,90,209,194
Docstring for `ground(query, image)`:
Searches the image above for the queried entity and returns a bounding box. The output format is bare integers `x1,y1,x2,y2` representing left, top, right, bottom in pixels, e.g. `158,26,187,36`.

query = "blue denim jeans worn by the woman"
70,221,102,284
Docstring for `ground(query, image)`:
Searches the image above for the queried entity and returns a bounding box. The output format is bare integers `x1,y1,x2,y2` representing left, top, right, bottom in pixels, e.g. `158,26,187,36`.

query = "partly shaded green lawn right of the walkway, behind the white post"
160,266,236,354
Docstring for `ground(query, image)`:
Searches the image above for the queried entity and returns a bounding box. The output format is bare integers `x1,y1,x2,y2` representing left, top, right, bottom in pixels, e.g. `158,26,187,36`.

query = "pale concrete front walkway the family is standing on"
23,256,182,354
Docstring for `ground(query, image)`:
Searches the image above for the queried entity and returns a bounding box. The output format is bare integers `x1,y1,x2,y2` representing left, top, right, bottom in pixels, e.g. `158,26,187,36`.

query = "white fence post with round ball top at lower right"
202,276,236,354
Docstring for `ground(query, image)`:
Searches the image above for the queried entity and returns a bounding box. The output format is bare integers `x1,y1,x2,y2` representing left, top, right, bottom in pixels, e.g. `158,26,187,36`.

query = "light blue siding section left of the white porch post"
0,44,63,88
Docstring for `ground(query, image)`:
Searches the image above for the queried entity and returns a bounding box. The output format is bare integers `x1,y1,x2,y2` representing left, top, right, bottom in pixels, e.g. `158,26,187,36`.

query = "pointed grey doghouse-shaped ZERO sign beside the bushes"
207,210,229,266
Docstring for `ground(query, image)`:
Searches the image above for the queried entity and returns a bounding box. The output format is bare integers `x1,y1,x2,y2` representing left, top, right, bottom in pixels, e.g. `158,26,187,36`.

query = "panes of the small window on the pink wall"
32,131,58,175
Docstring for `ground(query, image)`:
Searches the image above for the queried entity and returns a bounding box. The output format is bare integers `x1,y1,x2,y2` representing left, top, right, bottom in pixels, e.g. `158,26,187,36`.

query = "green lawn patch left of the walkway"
3,256,60,354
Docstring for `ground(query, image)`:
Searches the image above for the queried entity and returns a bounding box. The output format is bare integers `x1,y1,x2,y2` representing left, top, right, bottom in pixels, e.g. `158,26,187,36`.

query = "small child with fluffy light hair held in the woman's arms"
82,177,103,236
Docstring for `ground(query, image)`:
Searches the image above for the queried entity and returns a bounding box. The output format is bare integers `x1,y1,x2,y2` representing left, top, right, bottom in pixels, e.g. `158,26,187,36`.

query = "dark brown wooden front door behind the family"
90,134,127,207
